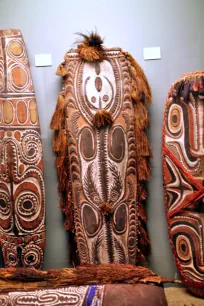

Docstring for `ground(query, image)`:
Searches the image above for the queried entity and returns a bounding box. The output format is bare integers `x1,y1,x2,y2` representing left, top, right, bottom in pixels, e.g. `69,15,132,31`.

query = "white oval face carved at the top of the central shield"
76,60,122,123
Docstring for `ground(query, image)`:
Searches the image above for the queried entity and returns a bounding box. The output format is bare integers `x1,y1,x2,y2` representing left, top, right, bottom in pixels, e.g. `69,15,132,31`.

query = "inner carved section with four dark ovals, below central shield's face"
78,121,128,263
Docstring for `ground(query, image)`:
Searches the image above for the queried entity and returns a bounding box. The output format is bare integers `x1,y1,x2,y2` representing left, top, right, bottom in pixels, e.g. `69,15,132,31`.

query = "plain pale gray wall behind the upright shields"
0,0,204,278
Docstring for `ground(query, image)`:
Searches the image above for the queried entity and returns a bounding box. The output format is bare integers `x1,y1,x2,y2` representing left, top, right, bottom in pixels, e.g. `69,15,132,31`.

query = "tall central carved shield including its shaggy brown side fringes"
51,33,150,264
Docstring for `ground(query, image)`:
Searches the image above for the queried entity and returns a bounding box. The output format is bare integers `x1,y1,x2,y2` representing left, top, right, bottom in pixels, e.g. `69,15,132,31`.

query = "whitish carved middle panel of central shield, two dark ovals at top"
79,126,128,206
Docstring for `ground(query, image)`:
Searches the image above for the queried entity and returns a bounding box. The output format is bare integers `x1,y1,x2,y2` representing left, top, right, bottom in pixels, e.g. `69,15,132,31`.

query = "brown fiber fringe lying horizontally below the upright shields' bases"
0,264,179,292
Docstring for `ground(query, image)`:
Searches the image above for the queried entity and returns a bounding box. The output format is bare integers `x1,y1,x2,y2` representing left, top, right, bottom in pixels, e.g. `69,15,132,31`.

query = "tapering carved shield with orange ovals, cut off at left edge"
0,30,45,268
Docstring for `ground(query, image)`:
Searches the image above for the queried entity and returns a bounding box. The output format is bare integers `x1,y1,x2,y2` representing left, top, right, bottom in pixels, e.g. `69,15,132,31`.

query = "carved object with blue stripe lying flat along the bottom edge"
0,284,167,306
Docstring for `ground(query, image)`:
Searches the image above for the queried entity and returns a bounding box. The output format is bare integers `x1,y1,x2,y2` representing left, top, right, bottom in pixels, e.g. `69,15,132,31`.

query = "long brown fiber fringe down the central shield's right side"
124,53,152,266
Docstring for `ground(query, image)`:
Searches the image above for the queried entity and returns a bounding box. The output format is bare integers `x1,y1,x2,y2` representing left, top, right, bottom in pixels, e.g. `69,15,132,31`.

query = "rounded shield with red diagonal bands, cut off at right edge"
163,71,204,297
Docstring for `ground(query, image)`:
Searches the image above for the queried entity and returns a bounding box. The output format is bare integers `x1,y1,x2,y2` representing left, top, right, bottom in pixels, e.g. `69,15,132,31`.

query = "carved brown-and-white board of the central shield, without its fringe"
64,50,137,264
